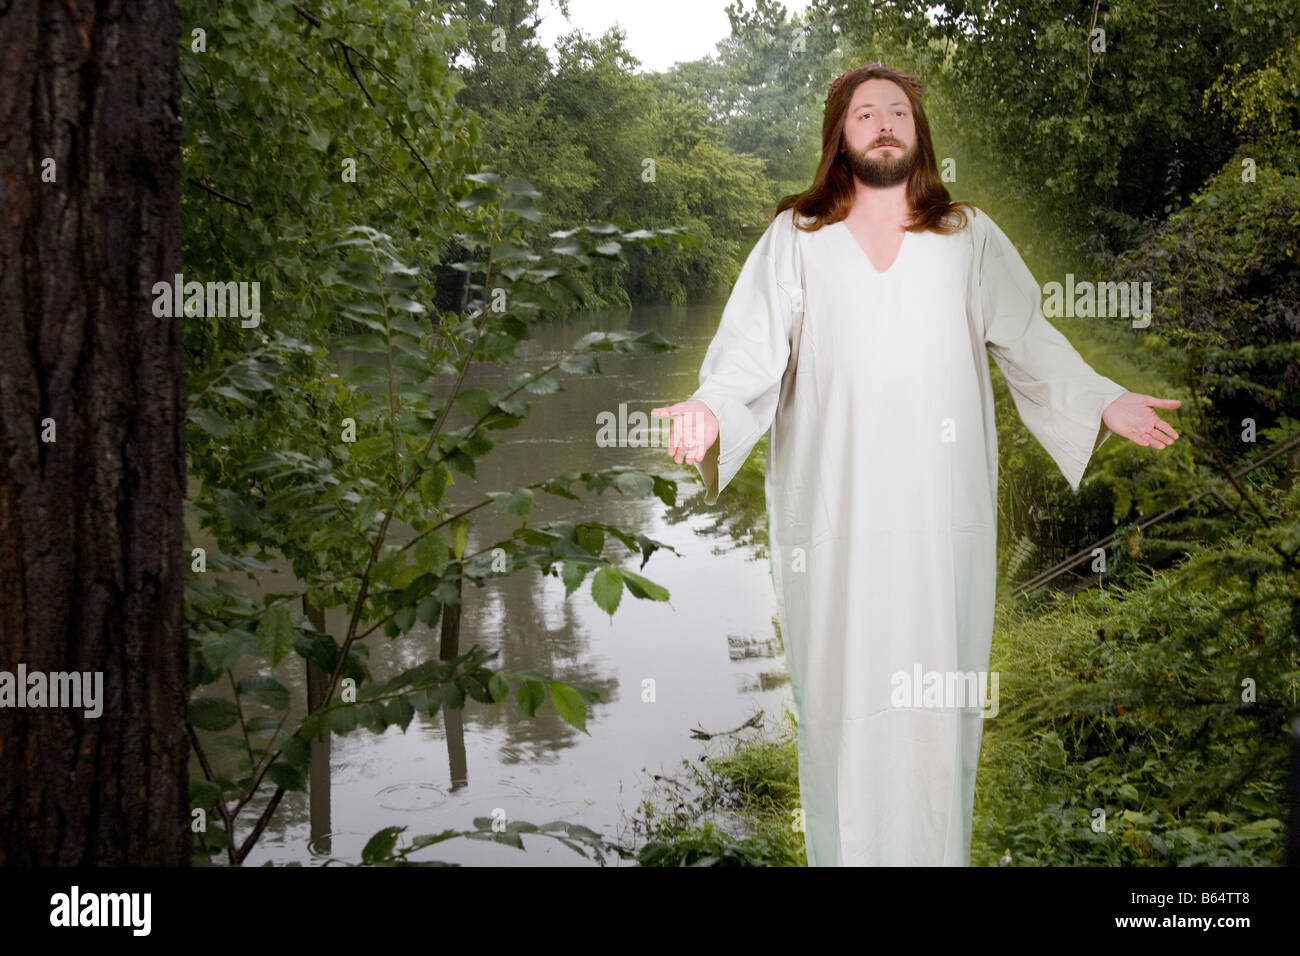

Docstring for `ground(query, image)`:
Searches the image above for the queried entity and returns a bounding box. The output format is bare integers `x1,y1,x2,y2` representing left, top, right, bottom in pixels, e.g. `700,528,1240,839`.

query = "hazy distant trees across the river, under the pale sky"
452,3,775,307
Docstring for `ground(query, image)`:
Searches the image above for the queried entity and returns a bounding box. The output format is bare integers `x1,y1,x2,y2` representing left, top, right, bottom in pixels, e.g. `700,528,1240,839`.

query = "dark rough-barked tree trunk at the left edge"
0,0,191,865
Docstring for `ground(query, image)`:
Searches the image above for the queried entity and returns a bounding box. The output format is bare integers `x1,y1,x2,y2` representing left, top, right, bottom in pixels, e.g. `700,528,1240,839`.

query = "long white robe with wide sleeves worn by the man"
692,211,1125,866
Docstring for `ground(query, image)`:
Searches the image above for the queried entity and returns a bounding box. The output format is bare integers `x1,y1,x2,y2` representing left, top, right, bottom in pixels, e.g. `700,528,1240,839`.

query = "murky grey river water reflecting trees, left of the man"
190,304,790,866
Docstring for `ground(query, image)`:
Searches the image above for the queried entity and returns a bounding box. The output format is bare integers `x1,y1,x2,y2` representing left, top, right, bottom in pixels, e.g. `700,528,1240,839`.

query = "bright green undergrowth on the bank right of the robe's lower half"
972,476,1300,865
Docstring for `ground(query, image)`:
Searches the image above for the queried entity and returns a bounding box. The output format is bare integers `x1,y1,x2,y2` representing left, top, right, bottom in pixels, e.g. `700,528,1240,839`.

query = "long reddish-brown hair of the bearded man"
776,64,975,233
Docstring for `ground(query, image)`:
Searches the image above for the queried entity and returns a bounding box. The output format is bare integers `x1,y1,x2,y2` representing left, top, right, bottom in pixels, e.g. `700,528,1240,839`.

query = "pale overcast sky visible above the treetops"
527,0,809,72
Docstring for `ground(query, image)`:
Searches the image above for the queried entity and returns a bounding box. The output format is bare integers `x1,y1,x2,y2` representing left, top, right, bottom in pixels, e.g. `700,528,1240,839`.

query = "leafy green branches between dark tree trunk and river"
182,0,696,864
